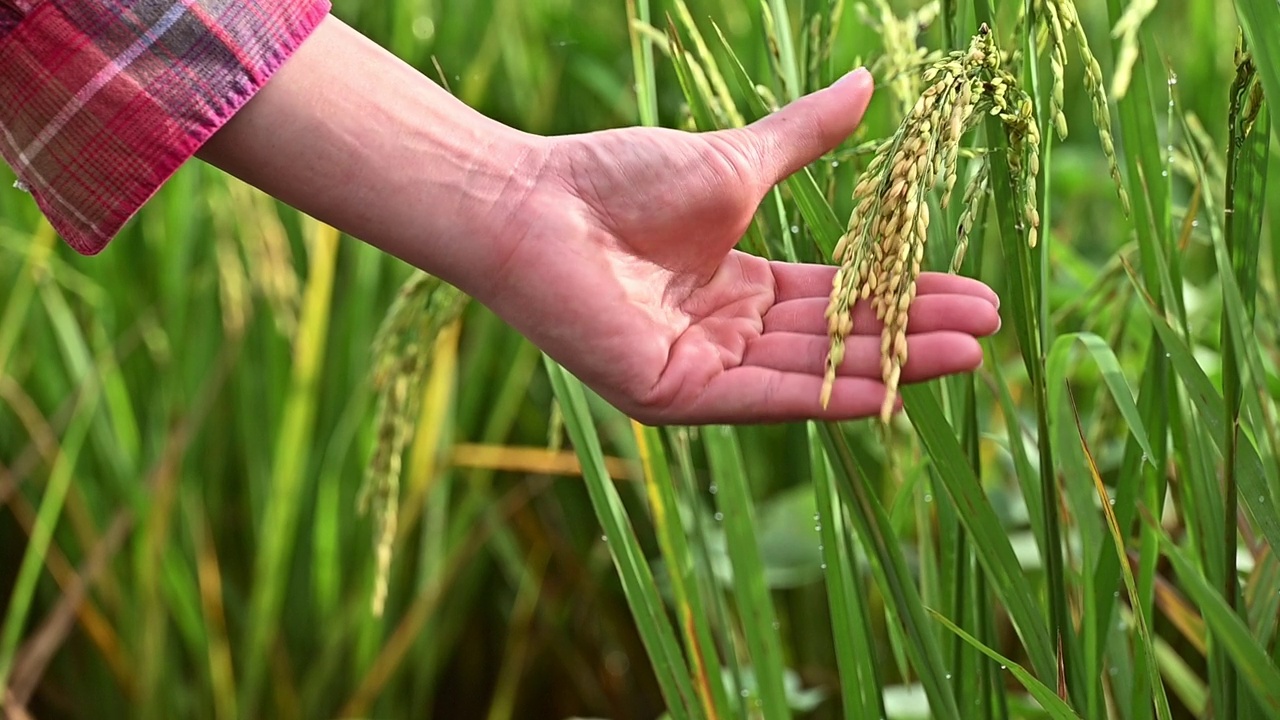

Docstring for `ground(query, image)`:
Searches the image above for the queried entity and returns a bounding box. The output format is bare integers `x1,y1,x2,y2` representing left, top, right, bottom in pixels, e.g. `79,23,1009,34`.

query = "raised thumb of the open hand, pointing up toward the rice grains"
735,68,874,187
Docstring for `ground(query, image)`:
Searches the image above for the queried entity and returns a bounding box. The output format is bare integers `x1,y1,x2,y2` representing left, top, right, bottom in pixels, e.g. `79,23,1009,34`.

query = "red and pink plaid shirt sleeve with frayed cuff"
0,0,330,255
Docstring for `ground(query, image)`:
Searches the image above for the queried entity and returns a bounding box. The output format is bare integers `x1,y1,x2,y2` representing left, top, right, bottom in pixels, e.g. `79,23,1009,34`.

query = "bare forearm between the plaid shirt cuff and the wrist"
198,17,545,299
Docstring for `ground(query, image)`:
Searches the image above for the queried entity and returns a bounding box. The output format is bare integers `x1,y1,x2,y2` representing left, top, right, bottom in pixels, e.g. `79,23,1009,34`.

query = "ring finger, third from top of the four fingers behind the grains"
742,332,982,383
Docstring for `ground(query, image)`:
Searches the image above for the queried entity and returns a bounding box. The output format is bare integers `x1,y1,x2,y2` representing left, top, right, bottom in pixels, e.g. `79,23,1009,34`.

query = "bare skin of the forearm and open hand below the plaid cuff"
200,17,1000,424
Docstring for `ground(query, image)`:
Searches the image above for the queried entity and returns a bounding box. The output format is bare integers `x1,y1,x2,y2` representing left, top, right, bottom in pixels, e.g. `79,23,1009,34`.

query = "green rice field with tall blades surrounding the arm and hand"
0,0,1280,720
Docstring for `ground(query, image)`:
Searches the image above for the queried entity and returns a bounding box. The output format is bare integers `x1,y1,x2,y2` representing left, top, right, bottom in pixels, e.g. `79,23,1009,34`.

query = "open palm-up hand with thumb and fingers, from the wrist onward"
486,70,1000,424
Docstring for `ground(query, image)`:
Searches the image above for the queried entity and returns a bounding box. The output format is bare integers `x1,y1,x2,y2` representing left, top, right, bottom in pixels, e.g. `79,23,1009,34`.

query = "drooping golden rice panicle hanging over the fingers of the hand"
822,24,1039,423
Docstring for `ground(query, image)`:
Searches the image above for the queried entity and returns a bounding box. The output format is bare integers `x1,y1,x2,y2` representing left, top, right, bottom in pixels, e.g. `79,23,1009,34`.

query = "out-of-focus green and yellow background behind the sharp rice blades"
0,0,1280,720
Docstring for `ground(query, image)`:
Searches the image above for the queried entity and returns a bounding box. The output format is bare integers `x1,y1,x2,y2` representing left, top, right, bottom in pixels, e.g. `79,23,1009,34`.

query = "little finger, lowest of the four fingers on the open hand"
660,366,901,425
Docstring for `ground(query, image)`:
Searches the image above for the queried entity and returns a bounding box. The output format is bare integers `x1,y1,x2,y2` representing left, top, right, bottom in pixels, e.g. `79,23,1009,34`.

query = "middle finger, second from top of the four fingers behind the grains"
764,293,1000,337
